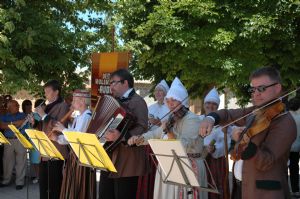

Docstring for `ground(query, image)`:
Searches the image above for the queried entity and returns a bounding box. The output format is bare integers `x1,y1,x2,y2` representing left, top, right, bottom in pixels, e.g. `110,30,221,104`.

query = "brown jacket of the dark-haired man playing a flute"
43,102,69,160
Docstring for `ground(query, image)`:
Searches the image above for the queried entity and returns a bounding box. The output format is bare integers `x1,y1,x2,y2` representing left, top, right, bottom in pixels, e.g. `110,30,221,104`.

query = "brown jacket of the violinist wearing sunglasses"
217,107,296,199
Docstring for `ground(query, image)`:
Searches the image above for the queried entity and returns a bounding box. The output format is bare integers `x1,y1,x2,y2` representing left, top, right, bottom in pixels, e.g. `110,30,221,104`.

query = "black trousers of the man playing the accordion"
99,171,138,199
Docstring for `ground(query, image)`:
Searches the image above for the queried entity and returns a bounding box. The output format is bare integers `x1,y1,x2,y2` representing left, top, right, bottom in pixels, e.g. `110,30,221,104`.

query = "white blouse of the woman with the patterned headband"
57,109,92,145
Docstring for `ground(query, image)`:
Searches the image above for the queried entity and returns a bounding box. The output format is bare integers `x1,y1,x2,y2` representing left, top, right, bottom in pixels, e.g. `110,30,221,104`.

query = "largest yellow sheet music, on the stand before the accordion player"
63,132,117,172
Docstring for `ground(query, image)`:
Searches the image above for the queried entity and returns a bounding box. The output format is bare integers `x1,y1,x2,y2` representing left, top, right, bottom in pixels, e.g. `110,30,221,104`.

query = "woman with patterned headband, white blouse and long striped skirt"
53,89,96,199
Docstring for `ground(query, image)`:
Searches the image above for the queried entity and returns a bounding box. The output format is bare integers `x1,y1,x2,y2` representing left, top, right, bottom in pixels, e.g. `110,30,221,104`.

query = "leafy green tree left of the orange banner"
0,0,110,96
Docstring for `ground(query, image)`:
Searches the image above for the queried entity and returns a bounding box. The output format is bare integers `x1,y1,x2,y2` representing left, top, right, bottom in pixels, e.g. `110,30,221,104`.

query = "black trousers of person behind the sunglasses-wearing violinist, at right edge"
289,152,299,192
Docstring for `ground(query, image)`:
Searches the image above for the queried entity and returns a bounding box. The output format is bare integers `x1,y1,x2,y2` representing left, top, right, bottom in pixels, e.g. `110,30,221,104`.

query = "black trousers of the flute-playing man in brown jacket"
39,160,64,199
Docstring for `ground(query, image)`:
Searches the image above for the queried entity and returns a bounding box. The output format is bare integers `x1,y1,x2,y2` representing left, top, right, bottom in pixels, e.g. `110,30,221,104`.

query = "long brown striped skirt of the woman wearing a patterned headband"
60,151,97,199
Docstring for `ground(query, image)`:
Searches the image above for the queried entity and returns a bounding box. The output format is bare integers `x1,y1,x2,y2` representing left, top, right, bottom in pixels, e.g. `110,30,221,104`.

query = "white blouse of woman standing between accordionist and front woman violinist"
148,102,170,130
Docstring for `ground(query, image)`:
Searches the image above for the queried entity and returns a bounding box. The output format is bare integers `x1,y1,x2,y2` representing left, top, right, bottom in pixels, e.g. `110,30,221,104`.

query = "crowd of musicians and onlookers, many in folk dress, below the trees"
0,67,300,199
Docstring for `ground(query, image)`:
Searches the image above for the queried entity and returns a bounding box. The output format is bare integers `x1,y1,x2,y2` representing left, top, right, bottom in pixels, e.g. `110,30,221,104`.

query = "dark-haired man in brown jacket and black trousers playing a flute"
35,80,69,199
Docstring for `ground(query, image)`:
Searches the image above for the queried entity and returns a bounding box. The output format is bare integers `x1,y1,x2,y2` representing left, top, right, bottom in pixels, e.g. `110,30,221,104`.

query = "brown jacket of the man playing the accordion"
110,91,148,178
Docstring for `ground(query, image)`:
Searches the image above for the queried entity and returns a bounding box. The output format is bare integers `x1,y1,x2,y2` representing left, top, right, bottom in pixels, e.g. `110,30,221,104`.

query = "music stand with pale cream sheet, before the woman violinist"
148,139,219,193
